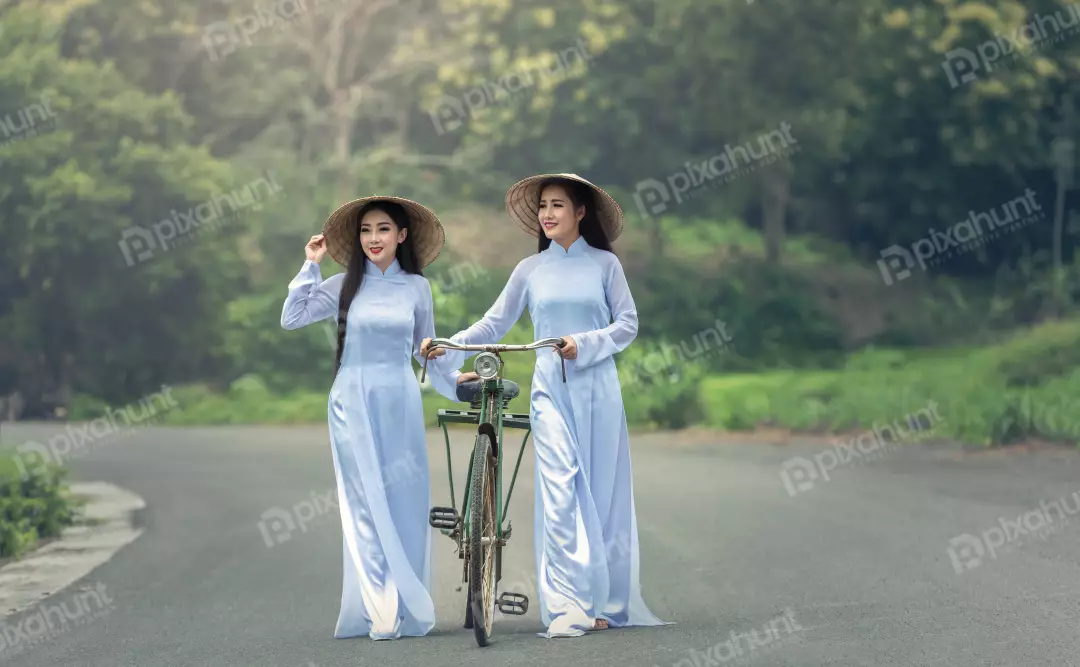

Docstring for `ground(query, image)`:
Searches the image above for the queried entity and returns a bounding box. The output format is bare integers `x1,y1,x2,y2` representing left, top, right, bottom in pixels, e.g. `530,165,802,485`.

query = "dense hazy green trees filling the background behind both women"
0,0,1080,439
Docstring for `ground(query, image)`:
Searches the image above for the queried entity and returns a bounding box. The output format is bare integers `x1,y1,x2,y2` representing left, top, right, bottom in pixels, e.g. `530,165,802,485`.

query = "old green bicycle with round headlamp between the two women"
420,338,566,646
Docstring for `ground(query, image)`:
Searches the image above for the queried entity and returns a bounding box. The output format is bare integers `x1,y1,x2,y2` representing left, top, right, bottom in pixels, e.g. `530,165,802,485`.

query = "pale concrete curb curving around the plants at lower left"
0,481,146,620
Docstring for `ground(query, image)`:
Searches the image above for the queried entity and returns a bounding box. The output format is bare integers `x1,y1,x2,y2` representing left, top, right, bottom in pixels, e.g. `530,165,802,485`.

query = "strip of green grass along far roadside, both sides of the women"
73,319,1080,446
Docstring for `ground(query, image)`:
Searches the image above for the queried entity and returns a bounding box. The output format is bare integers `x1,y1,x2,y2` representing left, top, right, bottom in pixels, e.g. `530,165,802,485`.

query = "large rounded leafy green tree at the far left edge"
0,4,243,404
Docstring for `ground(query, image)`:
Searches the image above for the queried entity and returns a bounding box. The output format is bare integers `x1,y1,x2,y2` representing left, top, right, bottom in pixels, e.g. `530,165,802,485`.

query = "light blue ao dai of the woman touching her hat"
281,259,457,639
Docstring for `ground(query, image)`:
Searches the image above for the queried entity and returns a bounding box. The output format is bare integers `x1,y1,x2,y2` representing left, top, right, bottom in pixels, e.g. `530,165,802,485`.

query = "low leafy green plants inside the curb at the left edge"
0,449,82,560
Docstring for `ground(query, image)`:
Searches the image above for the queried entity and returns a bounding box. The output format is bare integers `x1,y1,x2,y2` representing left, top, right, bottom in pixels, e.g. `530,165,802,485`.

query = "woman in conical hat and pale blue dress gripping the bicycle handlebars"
421,174,666,638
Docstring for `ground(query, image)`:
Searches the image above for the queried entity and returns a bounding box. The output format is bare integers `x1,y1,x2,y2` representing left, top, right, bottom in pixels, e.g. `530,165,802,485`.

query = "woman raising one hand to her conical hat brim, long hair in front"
281,196,456,640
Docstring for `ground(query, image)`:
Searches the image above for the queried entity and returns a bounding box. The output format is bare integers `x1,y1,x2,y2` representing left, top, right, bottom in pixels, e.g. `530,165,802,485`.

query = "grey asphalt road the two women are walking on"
0,424,1080,667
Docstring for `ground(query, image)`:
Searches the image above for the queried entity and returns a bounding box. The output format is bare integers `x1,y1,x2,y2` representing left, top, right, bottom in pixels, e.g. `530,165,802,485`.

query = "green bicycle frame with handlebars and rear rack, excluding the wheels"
420,338,566,569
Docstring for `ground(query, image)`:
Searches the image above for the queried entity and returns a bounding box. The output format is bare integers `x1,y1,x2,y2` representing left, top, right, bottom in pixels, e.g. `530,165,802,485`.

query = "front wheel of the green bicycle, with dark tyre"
469,433,497,646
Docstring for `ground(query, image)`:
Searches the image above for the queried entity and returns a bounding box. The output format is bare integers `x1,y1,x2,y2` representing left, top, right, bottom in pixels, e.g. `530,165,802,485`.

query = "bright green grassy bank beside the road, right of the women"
699,321,1080,446
